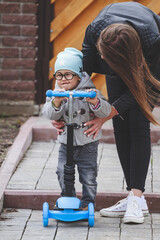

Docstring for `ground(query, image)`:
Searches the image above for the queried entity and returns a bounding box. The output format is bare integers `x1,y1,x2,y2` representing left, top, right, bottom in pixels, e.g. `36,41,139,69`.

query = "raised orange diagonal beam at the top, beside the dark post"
50,0,93,42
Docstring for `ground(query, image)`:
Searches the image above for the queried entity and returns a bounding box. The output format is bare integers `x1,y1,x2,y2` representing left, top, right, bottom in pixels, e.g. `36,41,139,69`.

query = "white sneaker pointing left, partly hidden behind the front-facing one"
100,193,149,217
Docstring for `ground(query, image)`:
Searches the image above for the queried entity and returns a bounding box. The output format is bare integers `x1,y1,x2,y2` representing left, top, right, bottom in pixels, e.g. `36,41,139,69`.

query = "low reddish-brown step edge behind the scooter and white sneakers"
4,190,160,213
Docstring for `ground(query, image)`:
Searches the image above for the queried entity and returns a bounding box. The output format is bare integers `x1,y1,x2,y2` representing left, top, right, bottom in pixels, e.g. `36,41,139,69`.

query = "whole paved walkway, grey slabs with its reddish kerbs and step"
0,113,160,240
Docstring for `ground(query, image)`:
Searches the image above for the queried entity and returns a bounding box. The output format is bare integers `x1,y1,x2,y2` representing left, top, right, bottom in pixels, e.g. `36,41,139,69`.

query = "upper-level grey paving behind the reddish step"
7,141,160,193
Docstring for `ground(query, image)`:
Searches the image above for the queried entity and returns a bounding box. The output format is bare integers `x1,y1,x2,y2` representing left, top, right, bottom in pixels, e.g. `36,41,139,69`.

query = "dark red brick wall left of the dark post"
0,0,38,115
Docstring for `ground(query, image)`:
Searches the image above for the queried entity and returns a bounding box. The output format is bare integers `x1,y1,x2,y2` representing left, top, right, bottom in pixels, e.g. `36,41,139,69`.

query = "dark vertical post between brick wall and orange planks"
35,0,54,104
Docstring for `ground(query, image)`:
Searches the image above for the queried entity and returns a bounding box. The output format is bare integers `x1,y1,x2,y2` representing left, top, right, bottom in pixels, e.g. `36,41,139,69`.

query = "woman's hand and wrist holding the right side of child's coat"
84,107,117,139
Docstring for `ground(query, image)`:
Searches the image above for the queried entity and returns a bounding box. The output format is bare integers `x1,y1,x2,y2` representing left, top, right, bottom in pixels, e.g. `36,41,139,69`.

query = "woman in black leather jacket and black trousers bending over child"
51,2,160,223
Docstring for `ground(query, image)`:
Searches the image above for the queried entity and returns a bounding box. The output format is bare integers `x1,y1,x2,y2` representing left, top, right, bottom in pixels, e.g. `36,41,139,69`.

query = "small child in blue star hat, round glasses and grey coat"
43,48,111,209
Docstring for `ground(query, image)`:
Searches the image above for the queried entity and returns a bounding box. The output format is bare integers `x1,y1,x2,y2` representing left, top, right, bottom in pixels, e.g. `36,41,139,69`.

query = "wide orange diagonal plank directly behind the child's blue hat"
49,0,128,79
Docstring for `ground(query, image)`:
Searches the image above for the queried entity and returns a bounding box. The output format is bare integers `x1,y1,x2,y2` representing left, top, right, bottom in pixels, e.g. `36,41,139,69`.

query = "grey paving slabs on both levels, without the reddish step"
0,115,160,240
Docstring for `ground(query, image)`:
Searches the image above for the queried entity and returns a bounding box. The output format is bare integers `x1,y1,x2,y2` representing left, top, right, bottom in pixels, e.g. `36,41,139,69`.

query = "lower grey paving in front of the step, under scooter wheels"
0,209,160,240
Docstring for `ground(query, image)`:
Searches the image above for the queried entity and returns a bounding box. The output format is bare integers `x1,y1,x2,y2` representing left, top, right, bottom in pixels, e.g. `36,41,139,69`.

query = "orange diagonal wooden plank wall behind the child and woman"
49,0,160,97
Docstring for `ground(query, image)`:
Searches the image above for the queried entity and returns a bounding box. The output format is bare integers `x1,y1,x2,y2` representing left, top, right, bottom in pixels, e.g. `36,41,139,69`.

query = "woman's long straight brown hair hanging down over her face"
97,24,160,125
